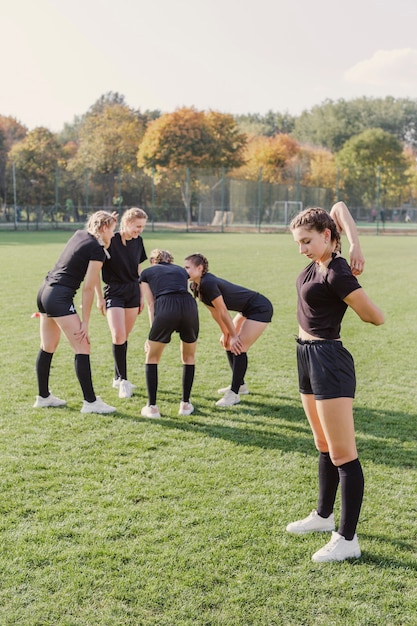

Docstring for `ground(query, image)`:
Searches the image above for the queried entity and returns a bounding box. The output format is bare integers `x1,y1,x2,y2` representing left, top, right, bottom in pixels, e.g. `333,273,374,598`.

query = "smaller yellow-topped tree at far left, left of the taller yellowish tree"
9,127,65,218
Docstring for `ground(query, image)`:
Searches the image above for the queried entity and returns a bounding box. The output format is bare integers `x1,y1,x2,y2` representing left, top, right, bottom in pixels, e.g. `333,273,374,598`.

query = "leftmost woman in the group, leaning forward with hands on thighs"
33,211,117,413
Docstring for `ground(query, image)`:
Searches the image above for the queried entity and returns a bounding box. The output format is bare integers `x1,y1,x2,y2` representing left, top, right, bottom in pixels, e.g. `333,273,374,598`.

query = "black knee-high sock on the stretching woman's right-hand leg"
338,459,365,541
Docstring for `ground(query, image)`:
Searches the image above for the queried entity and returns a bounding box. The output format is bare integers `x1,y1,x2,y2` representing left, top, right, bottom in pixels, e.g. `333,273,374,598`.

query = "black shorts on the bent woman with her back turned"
149,293,199,343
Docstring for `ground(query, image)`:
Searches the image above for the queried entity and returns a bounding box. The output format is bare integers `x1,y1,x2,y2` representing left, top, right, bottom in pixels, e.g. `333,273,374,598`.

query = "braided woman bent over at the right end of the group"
185,253,273,407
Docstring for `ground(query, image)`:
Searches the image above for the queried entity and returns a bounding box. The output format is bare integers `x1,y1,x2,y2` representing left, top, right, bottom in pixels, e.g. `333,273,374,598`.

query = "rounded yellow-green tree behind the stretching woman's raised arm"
336,128,410,207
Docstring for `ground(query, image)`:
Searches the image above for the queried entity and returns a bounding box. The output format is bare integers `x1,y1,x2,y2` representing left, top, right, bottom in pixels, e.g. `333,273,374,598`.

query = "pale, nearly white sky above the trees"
0,0,417,131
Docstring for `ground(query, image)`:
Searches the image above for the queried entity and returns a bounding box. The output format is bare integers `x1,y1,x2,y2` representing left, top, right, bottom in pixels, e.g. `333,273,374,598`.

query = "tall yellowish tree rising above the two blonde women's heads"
69,102,144,207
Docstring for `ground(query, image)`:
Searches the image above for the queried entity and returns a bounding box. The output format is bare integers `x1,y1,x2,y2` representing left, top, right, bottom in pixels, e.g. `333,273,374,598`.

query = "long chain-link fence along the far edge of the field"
0,168,417,232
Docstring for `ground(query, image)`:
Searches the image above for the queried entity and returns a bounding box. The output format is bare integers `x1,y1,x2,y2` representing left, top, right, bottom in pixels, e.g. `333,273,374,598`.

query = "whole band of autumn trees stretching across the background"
0,92,417,221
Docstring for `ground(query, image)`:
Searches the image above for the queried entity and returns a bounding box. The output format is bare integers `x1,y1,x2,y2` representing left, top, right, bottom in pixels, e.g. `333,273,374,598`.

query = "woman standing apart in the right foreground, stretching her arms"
287,208,384,562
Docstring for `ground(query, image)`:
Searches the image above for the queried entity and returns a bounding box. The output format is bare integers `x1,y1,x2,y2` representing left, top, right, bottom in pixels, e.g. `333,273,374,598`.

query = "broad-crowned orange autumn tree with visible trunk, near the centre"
137,107,246,223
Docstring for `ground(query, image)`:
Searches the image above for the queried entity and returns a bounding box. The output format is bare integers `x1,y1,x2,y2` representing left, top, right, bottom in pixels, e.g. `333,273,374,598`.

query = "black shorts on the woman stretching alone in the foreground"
297,338,356,400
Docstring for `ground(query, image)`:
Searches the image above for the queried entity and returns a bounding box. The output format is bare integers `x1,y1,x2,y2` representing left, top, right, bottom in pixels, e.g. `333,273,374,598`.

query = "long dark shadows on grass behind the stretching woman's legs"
117,392,417,469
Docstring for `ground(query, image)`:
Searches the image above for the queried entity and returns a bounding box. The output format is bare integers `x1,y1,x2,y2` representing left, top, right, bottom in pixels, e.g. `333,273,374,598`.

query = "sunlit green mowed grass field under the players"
0,231,417,626
